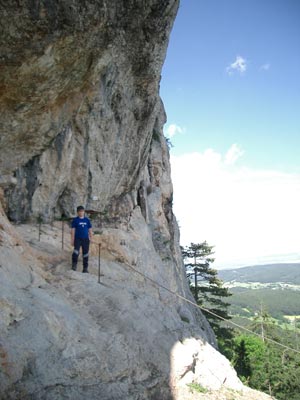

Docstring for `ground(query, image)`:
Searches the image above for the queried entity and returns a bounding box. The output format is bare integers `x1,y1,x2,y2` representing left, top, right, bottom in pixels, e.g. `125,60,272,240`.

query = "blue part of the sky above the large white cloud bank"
161,0,300,168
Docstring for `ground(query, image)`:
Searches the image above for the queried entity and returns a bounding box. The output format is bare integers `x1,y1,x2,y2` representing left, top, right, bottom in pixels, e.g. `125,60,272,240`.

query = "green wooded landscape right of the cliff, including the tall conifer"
182,242,300,400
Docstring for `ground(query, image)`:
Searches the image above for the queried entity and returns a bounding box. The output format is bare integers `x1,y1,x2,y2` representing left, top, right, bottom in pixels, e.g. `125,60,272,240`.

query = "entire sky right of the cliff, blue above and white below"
160,0,300,268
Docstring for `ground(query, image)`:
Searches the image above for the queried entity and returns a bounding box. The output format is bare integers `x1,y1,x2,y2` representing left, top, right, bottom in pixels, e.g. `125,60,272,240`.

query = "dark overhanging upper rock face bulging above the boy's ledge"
0,0,178,221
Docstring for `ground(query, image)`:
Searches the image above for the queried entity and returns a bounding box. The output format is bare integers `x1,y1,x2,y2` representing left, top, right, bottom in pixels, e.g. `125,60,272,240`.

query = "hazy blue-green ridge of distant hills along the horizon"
218,263,300,285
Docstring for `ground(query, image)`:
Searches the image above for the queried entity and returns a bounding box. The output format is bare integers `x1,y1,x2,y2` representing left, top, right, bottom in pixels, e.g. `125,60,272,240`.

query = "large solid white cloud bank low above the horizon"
171,145,300,267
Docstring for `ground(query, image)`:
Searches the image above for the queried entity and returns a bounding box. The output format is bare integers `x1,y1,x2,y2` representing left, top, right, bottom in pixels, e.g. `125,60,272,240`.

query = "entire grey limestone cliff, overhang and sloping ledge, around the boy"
0,0,272,400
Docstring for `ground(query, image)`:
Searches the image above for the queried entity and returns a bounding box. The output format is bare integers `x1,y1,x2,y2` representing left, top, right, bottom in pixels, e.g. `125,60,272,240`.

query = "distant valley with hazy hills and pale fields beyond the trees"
218,263,300,323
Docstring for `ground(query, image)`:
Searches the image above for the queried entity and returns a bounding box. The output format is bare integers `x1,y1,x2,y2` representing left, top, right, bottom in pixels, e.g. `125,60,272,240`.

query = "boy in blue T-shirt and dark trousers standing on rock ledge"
71,206,93,273
